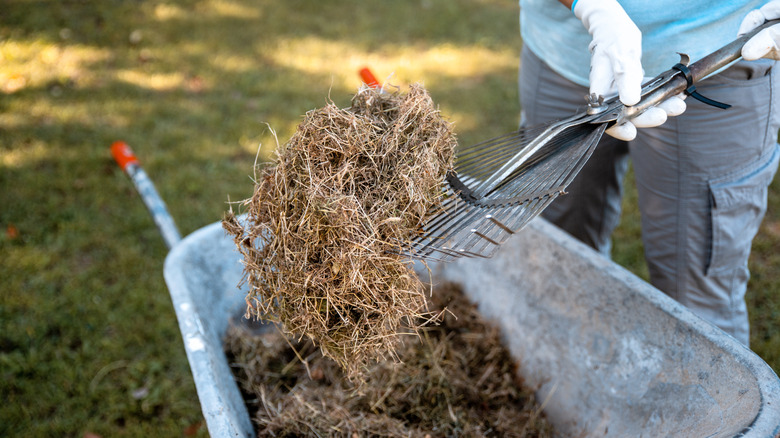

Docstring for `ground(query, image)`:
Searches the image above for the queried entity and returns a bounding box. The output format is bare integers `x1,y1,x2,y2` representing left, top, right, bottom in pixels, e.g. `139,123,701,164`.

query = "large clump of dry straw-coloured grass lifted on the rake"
224,85,457,377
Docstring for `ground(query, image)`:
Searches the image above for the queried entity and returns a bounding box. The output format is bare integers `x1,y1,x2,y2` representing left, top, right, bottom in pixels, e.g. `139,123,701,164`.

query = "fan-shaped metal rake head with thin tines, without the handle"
402,119,606,261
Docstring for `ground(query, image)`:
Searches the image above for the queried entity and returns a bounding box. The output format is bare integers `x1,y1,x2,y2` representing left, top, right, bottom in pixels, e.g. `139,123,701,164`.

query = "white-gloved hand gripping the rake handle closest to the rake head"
572,0,685,141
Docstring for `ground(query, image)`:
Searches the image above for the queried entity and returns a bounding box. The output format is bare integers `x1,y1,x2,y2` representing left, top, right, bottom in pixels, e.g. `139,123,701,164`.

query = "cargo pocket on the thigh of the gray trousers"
705,145,780,276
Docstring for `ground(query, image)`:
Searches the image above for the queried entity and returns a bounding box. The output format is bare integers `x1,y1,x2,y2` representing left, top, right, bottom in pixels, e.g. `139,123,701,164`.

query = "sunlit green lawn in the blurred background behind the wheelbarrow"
0,0,780,437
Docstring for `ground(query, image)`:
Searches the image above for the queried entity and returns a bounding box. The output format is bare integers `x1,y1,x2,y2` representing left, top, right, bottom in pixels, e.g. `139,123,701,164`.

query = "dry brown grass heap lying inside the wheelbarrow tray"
225,285,552,438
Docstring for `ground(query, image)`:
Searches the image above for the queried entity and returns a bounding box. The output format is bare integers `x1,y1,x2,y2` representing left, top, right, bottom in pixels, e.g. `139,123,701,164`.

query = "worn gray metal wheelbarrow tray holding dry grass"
165,219,780,437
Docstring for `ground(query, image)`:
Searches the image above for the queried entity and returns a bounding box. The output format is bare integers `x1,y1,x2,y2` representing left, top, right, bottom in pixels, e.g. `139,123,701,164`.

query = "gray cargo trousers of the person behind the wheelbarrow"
520,45,780,345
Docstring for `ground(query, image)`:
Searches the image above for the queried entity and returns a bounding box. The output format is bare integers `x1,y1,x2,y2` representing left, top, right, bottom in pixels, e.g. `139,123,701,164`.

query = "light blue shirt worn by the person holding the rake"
520,0,766,86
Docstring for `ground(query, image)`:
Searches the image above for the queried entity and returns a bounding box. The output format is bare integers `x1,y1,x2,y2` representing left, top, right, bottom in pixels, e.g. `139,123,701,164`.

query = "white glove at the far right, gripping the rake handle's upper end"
737,0,780,61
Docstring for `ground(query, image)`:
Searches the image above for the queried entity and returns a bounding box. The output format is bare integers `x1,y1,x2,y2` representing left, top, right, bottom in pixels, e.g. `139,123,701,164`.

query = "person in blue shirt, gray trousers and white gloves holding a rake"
519,0,780,345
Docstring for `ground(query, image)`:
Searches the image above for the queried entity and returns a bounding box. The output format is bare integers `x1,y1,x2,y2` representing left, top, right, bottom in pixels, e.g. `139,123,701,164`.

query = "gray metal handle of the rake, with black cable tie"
622,20,780,119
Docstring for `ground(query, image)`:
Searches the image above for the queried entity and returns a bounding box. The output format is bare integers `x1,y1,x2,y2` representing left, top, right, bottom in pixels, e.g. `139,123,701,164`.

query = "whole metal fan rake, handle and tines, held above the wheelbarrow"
400,20,780,261
